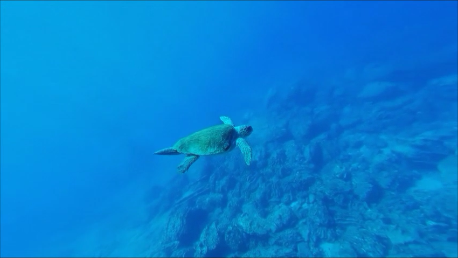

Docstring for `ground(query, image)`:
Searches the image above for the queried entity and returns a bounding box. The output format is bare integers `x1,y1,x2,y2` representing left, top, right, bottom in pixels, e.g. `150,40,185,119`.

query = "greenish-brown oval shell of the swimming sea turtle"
173,124,237,155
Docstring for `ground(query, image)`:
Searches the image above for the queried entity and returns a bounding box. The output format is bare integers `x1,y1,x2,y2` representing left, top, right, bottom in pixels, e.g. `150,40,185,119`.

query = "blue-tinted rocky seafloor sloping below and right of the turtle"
146,66,458,257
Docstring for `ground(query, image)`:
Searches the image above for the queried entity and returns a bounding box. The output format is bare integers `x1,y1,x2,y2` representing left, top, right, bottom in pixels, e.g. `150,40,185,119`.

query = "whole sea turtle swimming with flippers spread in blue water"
154,116,253,173
